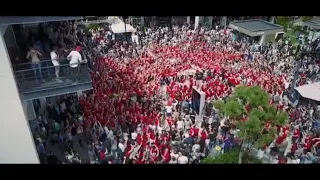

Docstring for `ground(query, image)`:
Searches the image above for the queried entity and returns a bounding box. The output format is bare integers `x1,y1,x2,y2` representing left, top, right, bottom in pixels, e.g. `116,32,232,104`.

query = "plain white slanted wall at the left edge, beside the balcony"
0,33,39,164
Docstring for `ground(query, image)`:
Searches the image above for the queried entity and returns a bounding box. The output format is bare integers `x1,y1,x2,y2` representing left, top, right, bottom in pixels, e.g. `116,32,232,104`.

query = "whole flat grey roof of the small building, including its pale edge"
229,19,283,36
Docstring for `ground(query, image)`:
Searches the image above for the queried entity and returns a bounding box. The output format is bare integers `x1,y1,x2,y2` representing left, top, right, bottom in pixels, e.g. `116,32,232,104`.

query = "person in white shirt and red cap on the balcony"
67,46,85,83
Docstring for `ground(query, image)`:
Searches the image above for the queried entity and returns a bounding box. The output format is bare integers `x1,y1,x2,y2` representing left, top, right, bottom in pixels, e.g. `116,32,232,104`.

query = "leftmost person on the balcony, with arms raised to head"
26,47,43,82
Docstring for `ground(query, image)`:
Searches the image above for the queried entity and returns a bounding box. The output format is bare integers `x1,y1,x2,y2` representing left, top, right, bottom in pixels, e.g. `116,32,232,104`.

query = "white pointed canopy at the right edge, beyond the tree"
295,82,320,101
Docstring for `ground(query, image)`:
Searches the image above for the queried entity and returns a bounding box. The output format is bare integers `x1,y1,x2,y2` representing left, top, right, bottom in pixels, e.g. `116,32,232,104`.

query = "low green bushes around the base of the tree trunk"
201,149,262,164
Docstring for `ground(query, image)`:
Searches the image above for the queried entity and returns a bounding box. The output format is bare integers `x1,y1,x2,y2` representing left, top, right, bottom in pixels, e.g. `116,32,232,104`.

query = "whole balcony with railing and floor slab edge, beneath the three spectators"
13,59,92,100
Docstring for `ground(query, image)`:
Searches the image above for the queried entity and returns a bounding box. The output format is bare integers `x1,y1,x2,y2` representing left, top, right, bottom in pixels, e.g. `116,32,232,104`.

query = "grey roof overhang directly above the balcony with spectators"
0,16,82,25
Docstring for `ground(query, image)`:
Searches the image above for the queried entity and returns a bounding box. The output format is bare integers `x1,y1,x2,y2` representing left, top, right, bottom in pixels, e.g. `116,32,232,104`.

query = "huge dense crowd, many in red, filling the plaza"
30,19,320,164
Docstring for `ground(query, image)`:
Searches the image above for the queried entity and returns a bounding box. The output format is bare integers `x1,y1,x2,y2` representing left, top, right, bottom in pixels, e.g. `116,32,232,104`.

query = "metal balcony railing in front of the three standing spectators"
13,59,91,93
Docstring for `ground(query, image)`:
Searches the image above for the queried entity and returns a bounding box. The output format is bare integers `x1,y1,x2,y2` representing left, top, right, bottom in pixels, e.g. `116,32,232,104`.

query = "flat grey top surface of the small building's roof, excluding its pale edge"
232,19,282,32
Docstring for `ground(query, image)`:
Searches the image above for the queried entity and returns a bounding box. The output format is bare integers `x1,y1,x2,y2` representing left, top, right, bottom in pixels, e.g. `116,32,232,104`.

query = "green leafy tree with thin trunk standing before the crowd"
214,86,288,164
